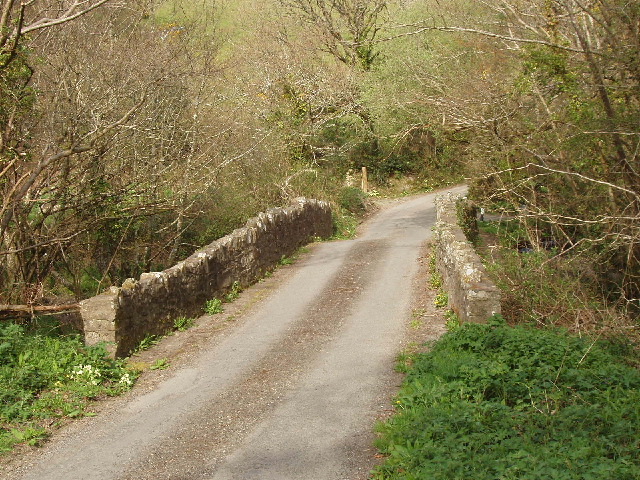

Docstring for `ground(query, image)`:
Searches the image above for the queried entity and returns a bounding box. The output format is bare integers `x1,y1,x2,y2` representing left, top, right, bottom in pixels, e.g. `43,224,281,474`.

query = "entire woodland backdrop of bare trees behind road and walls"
0,0,640,326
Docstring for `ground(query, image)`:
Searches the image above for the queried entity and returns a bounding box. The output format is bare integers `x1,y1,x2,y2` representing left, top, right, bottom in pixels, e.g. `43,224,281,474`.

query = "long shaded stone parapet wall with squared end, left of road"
80,198,333,357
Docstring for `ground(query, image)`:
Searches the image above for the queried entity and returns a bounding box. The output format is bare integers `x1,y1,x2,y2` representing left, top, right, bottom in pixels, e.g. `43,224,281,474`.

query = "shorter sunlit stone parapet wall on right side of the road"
434,194,500,323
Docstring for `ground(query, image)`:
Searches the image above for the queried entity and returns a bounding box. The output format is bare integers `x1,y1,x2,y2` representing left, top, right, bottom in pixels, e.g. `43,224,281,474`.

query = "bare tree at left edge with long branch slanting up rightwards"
0,0,132,302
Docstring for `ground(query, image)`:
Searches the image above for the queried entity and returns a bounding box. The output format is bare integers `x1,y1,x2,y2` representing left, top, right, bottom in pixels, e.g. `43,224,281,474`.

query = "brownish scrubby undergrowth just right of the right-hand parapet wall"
475,218,640,334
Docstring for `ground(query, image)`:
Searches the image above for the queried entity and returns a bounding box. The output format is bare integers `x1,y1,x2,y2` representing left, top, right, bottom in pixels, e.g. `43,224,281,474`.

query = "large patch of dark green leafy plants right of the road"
373,317,640,480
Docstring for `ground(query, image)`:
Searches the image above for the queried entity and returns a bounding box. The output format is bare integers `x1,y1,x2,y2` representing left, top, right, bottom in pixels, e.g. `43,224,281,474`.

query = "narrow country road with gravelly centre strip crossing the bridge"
0,187,464,480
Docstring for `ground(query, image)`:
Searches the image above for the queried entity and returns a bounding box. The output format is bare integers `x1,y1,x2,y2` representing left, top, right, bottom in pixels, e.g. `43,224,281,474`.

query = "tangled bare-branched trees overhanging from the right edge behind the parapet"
407,0,640,306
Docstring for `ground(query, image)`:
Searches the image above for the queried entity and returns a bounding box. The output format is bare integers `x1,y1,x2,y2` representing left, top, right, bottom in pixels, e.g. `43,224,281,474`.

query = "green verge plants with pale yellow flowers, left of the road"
0,319,135,453
